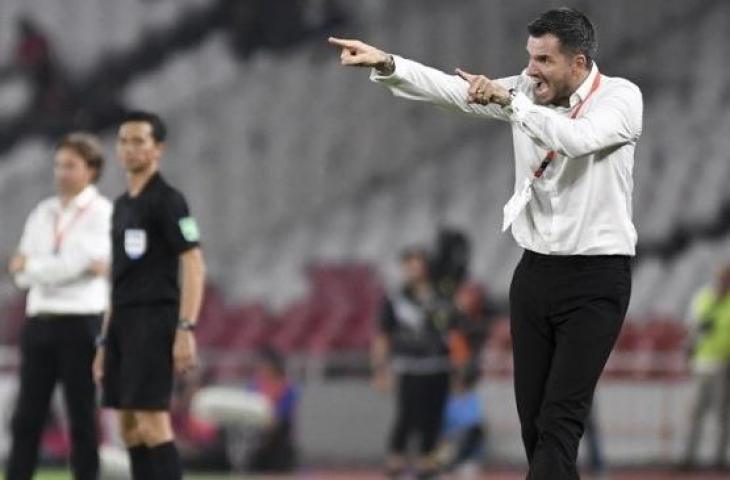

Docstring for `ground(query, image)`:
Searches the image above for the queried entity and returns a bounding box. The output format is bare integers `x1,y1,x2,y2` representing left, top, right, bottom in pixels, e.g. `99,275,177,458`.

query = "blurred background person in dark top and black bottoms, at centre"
372,248,454,480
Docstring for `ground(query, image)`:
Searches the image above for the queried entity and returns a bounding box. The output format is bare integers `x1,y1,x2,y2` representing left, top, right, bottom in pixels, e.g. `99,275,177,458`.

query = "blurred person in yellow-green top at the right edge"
681,265,730,470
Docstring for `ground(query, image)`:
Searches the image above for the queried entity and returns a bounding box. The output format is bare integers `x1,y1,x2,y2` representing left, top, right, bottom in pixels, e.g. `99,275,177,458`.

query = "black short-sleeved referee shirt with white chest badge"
112,173,200,307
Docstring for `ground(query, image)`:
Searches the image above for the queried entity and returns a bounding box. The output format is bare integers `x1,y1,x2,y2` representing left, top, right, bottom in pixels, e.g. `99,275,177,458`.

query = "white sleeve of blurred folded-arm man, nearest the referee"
16,204,111,285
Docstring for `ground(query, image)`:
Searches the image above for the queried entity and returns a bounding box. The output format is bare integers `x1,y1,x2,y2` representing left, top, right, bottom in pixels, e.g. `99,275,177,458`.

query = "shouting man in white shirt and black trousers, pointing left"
330,8,642,480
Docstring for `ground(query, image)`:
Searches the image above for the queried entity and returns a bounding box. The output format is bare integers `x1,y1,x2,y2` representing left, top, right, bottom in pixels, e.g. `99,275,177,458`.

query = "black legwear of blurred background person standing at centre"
390,373,450,456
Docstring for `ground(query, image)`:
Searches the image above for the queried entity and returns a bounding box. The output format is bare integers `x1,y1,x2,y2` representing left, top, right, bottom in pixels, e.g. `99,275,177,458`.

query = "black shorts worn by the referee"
102,305,179,410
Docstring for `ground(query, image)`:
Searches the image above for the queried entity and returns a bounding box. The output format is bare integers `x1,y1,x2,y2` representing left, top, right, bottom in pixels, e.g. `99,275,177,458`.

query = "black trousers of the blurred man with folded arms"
5,315,101,480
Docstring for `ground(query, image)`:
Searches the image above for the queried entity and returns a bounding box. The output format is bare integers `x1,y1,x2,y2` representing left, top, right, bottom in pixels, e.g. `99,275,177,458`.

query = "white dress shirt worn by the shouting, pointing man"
371,56,643,255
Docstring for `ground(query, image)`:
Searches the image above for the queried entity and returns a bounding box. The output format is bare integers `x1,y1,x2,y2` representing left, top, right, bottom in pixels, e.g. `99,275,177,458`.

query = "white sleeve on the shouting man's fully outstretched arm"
370,55,518,121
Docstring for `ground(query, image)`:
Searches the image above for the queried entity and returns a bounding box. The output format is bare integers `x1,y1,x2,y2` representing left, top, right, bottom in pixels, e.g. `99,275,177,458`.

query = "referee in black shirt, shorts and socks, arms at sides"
94,112,205,480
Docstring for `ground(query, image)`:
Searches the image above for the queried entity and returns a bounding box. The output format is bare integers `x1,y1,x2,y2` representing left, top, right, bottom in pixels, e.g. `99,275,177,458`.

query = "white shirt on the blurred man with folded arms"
15,186,112,316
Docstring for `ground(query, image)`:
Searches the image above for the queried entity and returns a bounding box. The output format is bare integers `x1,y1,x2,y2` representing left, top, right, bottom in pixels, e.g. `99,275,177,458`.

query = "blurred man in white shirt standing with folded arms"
6,133,112,480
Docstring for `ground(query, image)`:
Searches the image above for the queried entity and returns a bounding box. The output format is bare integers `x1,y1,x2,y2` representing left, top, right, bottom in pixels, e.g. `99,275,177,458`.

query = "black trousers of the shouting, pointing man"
510,251,631,480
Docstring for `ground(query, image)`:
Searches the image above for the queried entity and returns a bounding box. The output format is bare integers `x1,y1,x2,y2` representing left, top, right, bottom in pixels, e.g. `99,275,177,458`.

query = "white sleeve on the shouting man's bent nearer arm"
511,82,643,158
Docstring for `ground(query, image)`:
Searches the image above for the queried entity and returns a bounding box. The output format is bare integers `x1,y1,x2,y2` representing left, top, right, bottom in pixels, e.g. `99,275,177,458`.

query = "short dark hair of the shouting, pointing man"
527,7,598,67
